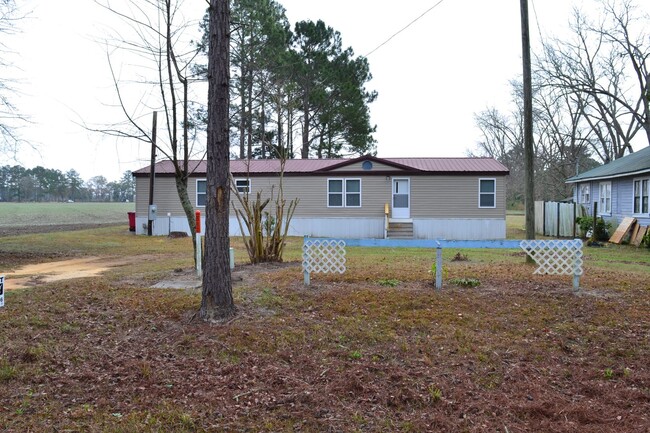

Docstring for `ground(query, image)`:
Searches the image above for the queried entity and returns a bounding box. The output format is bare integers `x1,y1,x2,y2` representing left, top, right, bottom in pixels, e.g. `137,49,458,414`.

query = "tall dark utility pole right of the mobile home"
520,0,535,239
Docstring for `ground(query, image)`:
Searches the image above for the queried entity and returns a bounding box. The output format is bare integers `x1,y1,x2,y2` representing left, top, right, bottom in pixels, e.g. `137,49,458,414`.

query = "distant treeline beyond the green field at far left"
0,165,135,202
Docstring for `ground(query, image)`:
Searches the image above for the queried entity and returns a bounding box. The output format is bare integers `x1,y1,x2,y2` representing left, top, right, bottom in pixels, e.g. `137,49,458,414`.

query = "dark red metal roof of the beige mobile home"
133,156,509,176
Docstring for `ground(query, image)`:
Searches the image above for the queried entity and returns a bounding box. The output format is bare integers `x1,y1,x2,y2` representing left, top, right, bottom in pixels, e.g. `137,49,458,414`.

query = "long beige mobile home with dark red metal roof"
133,156,508,239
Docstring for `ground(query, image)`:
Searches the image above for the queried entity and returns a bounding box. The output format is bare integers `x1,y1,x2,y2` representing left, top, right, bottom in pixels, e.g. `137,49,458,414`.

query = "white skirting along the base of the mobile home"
135,216,506,240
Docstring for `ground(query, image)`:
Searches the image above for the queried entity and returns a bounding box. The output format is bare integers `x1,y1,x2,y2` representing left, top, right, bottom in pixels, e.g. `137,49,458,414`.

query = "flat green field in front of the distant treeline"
0,203,135,227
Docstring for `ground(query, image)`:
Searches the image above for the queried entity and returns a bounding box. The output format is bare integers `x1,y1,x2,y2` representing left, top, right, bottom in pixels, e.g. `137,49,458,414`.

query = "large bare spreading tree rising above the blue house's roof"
538,0,650,163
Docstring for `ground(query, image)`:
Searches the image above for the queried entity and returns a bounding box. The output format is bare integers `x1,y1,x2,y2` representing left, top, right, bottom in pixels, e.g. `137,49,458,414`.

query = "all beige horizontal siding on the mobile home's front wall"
136,172,505,218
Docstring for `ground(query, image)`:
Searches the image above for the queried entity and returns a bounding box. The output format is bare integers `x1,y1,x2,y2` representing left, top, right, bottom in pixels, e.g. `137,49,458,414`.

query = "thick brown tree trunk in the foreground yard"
199,0,235,321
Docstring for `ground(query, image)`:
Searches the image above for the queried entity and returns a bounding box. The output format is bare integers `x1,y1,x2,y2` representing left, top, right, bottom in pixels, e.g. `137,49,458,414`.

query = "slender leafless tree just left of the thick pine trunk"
96,0,204,257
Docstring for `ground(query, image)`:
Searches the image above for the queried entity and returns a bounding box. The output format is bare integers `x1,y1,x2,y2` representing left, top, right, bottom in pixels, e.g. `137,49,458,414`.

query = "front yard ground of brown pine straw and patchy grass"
0,231,650,433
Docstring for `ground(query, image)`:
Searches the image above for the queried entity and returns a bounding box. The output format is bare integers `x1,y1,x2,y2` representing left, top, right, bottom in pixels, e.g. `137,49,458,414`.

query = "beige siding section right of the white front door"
411,175,506,218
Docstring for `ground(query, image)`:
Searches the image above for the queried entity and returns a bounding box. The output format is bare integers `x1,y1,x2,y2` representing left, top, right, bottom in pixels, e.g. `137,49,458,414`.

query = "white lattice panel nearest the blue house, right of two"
519,239,582,275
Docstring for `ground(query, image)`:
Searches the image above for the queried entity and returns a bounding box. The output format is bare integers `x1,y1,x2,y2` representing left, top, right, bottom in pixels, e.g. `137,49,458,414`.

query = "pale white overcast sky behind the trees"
9,0,647,180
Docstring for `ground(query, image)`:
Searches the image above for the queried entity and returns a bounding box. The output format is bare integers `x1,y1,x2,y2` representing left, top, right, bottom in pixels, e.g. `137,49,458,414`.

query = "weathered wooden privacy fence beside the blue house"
535,201,585,238
